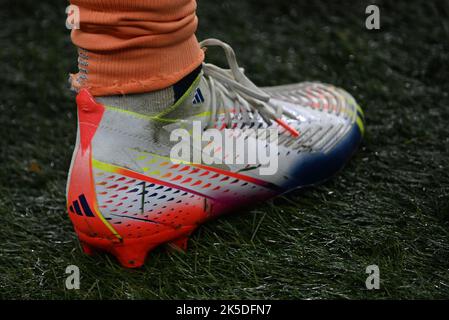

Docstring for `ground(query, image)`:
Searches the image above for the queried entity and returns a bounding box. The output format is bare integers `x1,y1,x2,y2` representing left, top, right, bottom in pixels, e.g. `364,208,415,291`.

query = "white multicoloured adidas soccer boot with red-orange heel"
67,39,364,267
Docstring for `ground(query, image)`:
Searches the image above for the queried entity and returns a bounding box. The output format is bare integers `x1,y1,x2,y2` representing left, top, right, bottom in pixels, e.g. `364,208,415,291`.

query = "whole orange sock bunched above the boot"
71,0,204,96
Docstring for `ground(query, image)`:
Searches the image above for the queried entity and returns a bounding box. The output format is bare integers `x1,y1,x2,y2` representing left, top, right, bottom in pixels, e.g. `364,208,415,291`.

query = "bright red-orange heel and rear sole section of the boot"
68,89,208,268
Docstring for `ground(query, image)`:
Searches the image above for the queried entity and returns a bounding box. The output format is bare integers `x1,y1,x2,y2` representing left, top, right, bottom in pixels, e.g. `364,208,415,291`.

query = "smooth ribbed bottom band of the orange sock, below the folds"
71,36,204,96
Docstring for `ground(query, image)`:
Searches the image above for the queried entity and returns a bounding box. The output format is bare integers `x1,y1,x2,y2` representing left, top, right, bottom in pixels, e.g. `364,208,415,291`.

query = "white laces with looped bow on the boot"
200,39,299,137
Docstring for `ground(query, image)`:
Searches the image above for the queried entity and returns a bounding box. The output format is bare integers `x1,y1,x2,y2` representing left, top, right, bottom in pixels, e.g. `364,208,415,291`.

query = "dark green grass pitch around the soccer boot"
0,0,449,299
